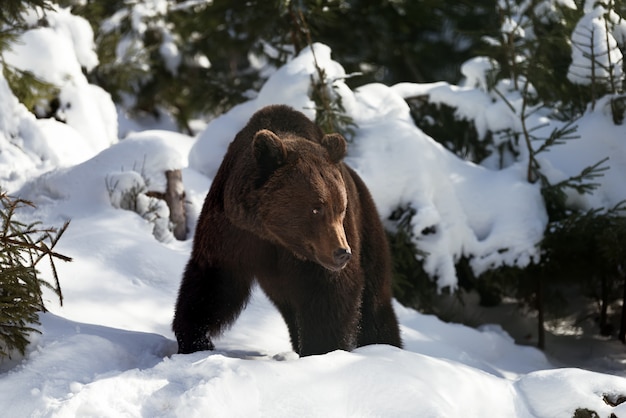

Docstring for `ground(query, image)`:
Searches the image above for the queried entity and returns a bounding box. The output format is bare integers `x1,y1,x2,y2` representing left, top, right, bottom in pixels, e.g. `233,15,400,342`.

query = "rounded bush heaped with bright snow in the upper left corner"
0,3,117,191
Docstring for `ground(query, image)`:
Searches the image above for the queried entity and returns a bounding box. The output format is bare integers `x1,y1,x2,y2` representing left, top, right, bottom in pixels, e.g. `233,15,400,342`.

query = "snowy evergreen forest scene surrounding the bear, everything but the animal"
0,0,626,418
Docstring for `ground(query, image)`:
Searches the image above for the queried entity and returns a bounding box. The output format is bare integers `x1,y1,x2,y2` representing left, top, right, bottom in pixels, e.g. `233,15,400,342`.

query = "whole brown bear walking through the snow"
173,105,401,356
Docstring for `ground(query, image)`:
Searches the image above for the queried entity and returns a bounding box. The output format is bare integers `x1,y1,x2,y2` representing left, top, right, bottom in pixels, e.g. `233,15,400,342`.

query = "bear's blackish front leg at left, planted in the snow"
172,258,251,354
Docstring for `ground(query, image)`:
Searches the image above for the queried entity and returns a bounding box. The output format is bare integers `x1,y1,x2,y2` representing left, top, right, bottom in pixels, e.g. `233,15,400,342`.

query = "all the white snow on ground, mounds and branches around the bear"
0,3,626,417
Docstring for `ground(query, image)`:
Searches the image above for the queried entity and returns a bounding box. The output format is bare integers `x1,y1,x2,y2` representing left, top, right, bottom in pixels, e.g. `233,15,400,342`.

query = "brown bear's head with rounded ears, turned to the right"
252,129,352,271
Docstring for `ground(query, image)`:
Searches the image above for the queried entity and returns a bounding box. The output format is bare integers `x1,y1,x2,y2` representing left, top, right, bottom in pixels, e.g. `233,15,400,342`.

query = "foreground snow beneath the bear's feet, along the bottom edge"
0,298,626,417
